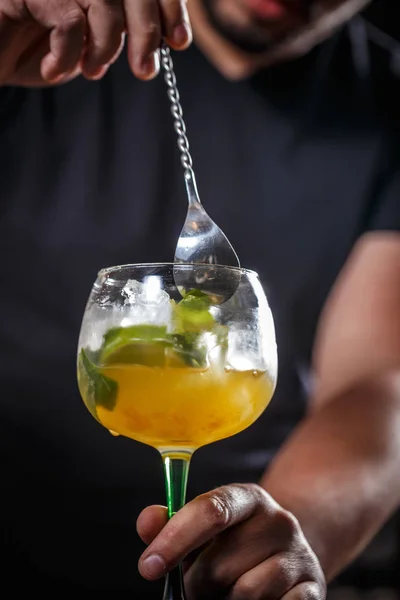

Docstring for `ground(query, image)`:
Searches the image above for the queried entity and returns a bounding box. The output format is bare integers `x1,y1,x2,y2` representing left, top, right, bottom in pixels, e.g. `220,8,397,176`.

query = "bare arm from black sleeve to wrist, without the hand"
261,233,400,579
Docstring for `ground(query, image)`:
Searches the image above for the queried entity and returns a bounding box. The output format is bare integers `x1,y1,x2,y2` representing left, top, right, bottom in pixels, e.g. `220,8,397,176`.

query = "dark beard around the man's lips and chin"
202,0,315,54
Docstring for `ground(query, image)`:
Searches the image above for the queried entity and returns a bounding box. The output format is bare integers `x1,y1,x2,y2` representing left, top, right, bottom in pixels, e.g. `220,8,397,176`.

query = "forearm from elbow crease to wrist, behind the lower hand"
261,380,400,580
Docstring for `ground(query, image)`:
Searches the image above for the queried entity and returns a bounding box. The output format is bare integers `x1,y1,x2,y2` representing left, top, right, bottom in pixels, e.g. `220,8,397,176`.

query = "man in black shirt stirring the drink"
0,0,400,600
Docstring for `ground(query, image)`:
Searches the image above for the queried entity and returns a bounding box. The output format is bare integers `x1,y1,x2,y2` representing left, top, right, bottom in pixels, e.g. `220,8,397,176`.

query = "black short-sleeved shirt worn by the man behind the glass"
0,14,400,598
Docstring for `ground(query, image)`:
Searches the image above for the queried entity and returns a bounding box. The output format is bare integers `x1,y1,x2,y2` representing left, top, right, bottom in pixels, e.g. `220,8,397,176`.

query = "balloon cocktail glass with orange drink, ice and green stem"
77,263,277,600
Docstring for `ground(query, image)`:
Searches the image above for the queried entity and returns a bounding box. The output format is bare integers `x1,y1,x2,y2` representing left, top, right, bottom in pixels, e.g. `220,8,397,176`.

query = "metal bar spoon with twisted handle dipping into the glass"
160,44,240,303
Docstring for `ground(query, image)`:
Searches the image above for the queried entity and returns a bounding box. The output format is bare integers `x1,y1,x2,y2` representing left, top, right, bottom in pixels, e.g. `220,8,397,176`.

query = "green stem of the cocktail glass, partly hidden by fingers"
161,450,192,600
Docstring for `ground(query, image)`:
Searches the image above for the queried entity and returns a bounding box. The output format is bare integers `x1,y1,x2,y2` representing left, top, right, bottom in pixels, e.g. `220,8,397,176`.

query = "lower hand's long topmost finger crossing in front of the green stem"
139,485,260,579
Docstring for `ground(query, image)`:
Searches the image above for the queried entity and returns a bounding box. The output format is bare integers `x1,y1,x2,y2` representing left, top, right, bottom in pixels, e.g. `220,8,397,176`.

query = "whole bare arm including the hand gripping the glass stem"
138,231,400,600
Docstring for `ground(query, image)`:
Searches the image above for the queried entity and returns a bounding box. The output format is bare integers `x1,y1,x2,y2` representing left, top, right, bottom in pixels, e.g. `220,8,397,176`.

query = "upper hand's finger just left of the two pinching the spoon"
82,0,125,77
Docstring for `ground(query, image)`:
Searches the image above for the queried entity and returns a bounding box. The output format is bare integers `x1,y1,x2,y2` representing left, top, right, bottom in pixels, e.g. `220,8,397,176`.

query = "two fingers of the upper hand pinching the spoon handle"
124,0,192,80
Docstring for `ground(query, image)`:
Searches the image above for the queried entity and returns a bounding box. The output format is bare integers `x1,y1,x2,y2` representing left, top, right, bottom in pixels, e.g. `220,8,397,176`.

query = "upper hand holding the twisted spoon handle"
0,0,192,86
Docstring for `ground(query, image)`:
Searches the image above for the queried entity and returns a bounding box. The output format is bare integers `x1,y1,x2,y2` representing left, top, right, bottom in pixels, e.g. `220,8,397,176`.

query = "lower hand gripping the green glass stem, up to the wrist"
137,484,326,600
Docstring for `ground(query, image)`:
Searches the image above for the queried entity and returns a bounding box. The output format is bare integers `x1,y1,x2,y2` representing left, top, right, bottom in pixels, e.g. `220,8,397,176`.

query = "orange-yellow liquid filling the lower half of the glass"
85,364,274,449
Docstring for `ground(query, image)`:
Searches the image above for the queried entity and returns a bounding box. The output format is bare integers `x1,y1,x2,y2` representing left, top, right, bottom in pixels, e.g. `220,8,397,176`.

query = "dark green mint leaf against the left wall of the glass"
78,348,118,418
